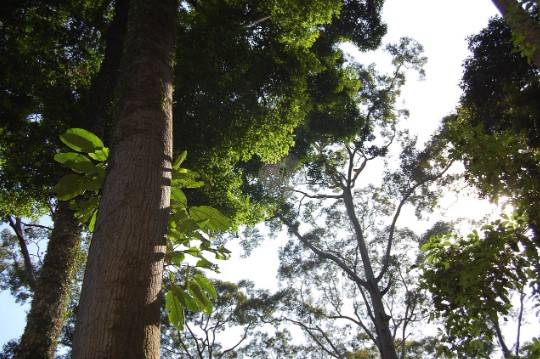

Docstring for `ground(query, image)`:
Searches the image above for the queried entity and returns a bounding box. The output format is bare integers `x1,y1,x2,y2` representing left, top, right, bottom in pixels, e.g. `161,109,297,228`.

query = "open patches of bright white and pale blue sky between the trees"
0,0,502,352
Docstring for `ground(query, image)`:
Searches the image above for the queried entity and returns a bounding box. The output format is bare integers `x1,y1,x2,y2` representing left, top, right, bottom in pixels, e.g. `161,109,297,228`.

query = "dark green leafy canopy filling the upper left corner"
0,0,109,217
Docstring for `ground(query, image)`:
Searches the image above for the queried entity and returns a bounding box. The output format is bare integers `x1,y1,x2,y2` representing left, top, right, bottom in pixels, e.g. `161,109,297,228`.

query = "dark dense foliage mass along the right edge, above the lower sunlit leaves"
441,19,540,240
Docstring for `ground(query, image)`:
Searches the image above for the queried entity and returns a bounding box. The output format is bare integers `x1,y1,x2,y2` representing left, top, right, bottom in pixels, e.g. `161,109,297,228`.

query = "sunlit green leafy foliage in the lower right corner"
421,217,540,358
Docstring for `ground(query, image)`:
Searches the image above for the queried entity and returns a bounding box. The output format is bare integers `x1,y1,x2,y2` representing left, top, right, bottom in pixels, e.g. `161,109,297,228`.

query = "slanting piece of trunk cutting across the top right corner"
492,0,540,68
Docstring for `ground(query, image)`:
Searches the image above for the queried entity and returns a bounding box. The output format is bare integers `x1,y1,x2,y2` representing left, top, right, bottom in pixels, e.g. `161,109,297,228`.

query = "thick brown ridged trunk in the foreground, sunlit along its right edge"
72,0,177,359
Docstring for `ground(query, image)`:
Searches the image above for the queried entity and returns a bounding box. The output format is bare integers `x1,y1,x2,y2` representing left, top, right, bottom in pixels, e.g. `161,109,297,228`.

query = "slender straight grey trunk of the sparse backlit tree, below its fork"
343,187,397,359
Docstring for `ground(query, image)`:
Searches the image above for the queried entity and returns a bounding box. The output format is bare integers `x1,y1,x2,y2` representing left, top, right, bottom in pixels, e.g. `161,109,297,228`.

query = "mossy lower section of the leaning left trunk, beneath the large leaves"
16,202,81,359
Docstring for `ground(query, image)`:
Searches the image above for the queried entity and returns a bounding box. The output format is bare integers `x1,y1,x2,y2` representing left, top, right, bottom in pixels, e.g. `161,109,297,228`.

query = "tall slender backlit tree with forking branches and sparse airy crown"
256,39,446,358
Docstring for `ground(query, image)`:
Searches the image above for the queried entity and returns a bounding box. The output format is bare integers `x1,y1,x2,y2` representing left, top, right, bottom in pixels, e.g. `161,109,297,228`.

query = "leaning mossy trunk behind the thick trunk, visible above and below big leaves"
17,0,127,358
